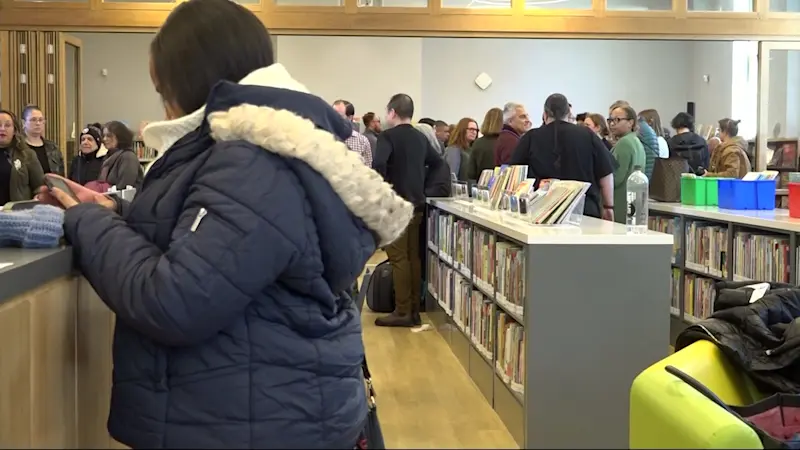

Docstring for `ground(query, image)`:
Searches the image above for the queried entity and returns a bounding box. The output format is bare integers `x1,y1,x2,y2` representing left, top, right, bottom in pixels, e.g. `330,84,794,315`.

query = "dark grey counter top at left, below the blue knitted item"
0,246,72,303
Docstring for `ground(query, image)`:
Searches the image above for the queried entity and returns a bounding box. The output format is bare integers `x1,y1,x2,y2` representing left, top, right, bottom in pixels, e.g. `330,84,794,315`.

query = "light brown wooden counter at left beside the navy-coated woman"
0,249,124,448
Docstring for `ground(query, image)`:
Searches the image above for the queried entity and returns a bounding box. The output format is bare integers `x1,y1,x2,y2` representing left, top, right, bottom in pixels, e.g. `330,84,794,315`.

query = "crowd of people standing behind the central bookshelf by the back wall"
334,94,751,229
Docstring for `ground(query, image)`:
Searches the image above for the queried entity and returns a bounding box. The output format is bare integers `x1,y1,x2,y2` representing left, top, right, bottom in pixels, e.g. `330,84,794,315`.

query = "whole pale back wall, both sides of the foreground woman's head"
76,33,744,133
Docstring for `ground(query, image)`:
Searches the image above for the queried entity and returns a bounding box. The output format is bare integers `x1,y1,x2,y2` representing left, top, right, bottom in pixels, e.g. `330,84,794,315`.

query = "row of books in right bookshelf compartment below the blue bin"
733,231,791,283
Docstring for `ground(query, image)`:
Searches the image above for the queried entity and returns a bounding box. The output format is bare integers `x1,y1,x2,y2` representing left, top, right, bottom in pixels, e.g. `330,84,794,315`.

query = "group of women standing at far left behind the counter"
0,105,143,206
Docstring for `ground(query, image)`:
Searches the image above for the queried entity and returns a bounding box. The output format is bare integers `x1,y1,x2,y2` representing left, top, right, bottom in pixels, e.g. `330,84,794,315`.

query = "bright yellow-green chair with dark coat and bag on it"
629,341,763,449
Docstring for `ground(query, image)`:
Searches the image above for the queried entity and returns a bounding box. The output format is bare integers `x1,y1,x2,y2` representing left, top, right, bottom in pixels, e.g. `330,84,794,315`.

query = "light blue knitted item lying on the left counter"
0,205,64,248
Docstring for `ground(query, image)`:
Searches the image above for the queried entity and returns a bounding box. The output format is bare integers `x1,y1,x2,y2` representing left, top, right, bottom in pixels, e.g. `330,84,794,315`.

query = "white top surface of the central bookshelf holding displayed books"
428,198,673,246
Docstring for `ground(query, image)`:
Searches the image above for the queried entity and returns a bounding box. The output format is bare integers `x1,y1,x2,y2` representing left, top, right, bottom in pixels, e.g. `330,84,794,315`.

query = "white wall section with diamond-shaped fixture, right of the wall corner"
422,39,691,123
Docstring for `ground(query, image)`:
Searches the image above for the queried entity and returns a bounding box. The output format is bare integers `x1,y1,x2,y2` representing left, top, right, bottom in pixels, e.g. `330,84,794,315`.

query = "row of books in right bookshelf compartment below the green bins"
684,221,728,278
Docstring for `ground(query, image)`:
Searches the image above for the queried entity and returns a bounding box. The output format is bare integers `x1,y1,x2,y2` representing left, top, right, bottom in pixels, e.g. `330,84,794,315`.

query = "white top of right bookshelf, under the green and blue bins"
650,201,800,233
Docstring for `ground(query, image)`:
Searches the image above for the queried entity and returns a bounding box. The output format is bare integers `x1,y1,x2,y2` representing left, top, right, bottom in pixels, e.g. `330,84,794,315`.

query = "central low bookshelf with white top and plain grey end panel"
425,199,673,448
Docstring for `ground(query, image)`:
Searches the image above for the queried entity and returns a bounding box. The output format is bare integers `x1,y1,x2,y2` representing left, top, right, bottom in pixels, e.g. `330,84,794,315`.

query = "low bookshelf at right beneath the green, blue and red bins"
650,201,800,343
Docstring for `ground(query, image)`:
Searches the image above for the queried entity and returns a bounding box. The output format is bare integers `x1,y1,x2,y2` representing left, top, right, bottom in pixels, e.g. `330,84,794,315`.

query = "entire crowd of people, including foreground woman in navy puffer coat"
0,0,764,449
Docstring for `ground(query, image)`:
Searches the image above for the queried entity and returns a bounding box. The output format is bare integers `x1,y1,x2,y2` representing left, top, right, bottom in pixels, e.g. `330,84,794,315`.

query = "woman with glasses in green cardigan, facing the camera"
608,106,645,223
